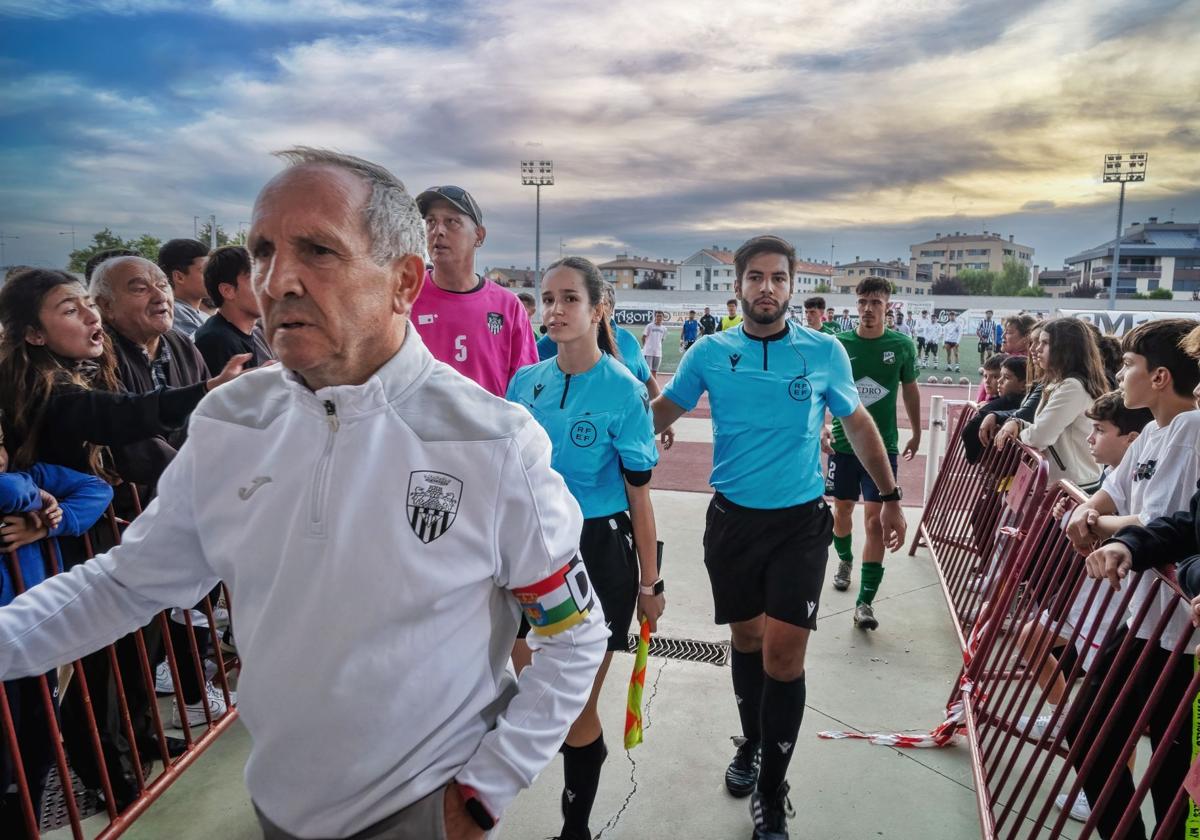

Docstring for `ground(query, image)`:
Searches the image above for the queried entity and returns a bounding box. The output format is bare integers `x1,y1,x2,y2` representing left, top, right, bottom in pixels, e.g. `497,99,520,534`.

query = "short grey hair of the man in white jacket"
274,146,425,265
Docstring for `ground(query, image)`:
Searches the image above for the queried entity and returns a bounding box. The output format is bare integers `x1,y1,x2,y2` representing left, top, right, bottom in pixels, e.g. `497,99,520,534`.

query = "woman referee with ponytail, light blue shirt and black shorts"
508,257,665,840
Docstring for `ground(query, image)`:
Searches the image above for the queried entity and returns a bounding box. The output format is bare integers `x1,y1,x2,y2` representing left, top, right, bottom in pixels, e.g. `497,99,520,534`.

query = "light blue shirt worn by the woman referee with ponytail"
506,353,659,520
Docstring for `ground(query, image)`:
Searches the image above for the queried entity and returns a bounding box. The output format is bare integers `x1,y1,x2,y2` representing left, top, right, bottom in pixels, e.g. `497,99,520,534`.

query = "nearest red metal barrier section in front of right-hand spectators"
962,482,1200,840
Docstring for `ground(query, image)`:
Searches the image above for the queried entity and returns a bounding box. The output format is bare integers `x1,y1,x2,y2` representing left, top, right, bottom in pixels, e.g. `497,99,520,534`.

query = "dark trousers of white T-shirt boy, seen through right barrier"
1068,626,1195,840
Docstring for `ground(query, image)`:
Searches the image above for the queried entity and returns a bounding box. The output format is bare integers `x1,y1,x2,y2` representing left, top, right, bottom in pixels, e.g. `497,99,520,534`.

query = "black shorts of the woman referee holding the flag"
517,511,641,650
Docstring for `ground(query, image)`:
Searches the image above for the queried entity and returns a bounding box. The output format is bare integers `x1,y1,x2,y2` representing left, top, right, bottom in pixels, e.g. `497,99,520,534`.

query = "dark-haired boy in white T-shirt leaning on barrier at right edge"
1067,318,1200,838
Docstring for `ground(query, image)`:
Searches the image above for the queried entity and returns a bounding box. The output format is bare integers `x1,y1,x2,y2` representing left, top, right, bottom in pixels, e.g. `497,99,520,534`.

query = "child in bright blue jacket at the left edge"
0,432,113,838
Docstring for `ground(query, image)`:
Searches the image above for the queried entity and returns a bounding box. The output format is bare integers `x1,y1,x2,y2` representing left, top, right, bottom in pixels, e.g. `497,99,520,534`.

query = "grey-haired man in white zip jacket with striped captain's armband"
0,149,608,840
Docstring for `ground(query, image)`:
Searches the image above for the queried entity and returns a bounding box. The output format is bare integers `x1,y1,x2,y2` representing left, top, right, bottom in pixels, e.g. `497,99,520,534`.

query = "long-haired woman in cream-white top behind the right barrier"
996,318,1109,492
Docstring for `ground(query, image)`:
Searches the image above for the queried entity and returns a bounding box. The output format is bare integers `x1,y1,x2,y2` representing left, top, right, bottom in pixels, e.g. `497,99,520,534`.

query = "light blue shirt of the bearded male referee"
662,323,859,510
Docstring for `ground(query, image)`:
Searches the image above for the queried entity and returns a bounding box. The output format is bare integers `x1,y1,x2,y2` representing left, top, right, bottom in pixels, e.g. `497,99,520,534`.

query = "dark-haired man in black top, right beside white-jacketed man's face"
192,245,274,371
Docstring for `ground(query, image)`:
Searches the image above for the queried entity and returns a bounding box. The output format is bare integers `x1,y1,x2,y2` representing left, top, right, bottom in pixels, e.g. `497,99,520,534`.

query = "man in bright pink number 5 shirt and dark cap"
412,186,538,397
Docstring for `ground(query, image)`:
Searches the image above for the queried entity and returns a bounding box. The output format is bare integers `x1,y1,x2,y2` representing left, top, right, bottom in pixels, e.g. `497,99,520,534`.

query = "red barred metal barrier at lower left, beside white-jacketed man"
0,509,239,840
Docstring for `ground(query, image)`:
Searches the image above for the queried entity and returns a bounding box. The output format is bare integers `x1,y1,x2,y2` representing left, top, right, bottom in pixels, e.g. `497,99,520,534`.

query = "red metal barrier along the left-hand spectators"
0,508,240,840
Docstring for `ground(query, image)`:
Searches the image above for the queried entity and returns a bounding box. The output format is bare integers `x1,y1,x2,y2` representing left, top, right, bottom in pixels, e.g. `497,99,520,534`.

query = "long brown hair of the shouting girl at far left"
0,269,119,480
